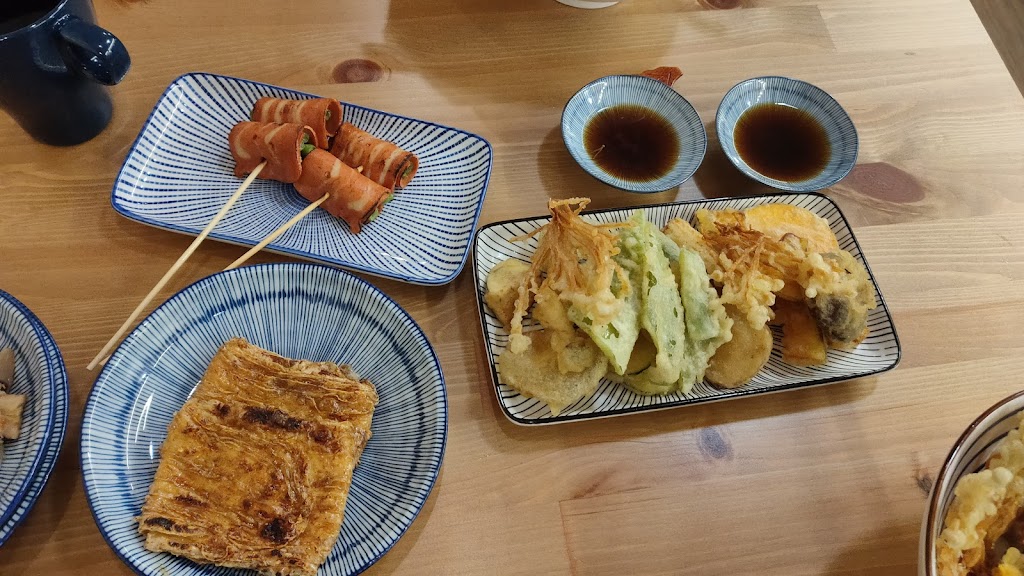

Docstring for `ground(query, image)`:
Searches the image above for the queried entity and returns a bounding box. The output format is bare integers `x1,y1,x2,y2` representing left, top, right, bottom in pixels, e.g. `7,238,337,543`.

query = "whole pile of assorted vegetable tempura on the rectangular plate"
484,198,874,405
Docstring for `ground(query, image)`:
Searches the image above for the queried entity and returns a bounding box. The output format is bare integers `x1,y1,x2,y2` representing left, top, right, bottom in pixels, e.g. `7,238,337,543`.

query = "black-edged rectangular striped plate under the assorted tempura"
473,194,900,424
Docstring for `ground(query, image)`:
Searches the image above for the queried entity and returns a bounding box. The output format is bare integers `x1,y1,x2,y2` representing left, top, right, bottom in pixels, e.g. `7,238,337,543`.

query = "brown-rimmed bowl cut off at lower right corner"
918,390,1024,576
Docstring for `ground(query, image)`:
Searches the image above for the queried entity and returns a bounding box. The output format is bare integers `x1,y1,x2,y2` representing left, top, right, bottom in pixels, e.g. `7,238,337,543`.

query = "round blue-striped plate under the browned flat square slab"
81,263,447,576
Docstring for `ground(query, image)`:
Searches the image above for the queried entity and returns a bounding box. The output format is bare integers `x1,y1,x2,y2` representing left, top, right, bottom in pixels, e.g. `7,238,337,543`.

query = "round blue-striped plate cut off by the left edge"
0,290,68,544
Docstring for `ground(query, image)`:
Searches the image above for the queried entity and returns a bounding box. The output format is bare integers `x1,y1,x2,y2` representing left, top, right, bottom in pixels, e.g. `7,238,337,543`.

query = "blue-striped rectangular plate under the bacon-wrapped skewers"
111,73,492,285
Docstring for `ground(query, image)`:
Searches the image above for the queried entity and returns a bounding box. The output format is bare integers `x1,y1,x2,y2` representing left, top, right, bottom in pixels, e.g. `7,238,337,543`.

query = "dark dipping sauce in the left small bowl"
583,105,679,182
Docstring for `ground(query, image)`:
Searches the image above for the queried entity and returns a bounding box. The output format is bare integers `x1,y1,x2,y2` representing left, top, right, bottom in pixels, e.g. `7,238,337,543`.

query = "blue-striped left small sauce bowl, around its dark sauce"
562,75,708,194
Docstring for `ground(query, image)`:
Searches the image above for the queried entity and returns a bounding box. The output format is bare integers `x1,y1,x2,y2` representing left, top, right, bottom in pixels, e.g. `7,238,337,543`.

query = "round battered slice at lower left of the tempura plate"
498,330,608,416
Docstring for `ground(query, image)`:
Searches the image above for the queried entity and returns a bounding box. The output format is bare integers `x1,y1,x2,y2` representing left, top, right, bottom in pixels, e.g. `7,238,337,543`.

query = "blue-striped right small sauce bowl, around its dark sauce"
715,76,859,192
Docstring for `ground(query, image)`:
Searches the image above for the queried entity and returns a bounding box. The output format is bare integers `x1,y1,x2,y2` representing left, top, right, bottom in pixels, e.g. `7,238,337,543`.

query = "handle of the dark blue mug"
58,16,131,86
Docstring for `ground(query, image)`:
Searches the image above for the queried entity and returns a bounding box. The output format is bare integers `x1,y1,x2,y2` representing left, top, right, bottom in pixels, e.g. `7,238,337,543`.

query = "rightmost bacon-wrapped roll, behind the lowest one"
331,122,420,190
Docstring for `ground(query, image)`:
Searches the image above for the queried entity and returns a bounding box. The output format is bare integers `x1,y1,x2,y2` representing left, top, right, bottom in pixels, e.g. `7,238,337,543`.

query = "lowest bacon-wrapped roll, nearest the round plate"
295,150,391,234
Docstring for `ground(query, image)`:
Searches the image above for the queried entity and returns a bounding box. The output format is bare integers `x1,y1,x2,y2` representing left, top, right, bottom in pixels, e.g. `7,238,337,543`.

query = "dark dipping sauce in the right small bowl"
732,104,831,182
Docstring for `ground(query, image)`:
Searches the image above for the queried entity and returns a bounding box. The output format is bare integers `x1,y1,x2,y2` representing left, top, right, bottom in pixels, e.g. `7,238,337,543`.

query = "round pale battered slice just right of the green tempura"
705,304,772,388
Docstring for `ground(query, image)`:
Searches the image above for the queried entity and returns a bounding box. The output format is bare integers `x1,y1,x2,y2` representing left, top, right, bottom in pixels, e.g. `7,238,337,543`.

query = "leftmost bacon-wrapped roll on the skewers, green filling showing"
227,122,317,183
